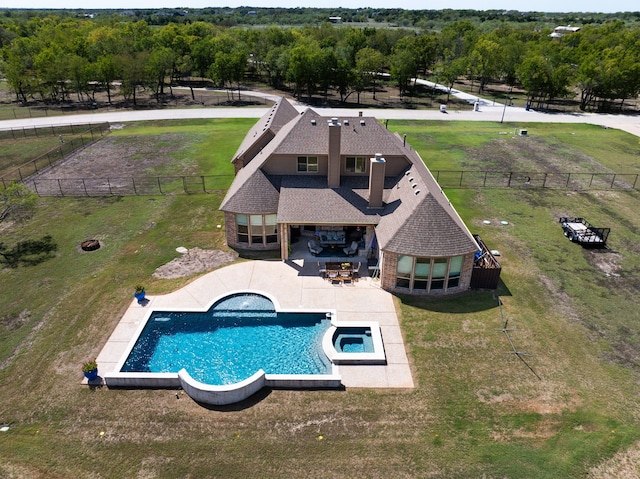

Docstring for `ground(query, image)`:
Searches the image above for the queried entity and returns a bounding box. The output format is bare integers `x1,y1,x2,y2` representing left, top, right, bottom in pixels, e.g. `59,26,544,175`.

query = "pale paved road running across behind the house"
0,90,640,136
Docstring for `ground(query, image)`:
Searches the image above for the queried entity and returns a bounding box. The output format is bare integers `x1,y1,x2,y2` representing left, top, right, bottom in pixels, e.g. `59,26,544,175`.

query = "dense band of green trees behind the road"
0,15,640,110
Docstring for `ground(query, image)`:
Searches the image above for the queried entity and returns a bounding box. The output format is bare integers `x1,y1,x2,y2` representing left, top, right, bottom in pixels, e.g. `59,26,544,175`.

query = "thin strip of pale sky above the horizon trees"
0,0,640,13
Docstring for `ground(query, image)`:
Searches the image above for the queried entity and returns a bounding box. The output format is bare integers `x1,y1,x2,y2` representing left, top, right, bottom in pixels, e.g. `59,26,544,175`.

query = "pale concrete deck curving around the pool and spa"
97,260,414,388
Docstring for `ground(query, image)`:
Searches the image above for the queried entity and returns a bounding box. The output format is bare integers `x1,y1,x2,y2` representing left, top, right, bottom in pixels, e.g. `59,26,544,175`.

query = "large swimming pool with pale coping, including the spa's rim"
104,291,386,405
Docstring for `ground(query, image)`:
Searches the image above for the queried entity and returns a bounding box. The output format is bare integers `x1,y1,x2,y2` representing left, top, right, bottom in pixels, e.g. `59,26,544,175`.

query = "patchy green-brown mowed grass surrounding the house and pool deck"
0,121,640,479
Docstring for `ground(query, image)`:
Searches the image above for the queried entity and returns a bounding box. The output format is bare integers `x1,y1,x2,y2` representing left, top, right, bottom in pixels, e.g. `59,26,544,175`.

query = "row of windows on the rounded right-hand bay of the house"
396,256,464,291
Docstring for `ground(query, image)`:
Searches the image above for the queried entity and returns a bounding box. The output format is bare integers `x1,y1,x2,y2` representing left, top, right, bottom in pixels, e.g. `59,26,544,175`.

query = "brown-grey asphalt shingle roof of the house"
220,98,478,257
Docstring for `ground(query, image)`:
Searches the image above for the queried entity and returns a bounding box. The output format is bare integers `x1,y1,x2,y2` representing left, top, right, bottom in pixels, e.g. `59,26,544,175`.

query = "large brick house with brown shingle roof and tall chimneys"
220,99,480,295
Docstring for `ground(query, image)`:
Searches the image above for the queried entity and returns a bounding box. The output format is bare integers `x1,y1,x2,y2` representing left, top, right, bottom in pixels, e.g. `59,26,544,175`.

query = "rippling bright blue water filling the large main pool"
121,293,331,385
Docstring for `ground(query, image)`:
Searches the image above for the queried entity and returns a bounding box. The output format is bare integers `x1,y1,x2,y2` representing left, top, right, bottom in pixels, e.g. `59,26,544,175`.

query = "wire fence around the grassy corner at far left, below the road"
0,123,110,187
